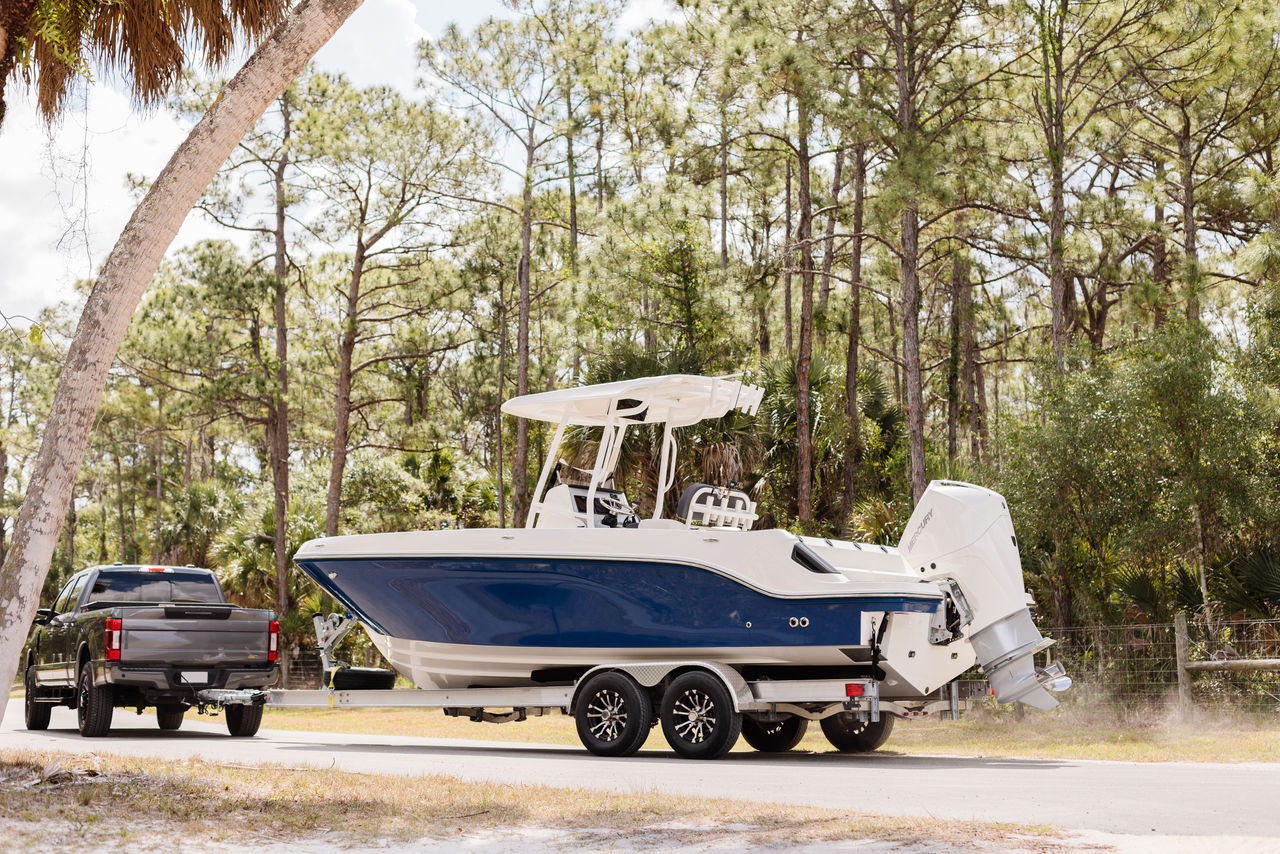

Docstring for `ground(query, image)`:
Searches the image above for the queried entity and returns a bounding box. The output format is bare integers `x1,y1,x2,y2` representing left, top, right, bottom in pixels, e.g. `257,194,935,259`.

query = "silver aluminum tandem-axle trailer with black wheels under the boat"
266,615,969,759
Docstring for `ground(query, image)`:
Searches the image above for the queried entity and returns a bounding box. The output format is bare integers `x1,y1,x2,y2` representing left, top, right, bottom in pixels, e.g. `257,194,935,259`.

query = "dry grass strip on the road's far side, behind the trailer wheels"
262,709,1280,762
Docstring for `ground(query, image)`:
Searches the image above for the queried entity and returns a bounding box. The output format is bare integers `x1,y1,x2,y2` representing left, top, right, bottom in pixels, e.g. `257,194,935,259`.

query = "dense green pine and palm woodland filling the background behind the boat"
17,0,1280,635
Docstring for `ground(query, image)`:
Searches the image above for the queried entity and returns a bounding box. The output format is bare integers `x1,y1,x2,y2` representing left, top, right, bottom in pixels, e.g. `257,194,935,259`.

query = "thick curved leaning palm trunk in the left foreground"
0,0,362,714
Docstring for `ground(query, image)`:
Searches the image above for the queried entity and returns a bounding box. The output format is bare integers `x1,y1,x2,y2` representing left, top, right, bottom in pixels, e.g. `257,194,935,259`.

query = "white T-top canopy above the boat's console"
502,374,764,426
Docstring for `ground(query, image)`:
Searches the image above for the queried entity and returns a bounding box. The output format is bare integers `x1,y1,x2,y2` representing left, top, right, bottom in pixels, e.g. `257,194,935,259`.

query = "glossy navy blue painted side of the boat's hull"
298,556,938,663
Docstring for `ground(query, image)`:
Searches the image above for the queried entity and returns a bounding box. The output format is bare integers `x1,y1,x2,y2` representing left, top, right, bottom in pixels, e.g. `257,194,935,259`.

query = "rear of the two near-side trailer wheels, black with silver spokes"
662,670,742,759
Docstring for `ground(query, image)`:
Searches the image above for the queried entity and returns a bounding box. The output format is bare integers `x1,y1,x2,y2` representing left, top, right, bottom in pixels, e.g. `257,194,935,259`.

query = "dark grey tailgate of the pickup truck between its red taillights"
120,604,269,666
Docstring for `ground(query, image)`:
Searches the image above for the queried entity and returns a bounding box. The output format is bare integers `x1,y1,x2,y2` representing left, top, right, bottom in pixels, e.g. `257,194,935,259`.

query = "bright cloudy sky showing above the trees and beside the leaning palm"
0,0,666,329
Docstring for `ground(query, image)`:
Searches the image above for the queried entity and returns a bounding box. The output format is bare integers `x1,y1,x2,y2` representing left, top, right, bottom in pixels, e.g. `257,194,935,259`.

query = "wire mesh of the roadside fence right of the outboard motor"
1047,620,1280,717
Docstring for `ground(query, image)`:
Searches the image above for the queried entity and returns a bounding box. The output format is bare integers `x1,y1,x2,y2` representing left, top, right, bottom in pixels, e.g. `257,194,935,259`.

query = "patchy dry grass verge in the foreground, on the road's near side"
0,750,1062,851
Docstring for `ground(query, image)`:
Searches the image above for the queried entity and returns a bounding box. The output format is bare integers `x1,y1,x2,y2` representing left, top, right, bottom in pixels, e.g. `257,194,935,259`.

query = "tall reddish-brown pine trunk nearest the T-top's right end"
796,97,813,526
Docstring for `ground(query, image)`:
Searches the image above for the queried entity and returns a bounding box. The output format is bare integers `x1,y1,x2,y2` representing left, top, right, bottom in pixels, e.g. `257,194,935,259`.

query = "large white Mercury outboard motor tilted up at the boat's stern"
899,480,1071,709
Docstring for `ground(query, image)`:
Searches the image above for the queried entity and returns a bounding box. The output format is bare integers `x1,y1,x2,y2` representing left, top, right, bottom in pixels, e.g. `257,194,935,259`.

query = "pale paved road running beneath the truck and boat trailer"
0,699,1280,844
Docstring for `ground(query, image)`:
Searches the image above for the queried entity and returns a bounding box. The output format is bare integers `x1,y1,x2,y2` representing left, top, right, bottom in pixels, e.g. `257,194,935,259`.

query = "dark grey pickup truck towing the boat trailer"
22,563,280,736
